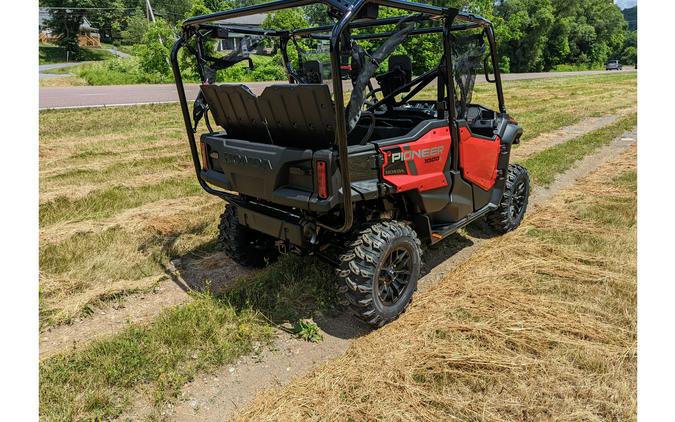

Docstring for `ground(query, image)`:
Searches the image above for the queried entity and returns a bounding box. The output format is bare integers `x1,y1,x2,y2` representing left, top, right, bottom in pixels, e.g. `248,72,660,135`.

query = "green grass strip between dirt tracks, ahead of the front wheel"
522,114,637,186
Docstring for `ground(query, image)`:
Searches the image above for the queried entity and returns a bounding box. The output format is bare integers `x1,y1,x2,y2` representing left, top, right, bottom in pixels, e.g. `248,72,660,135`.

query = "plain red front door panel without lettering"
459,127,501,190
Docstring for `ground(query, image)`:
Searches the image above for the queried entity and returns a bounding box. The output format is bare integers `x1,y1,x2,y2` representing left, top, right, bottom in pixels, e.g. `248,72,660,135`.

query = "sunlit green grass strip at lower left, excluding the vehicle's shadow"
40,294,272,420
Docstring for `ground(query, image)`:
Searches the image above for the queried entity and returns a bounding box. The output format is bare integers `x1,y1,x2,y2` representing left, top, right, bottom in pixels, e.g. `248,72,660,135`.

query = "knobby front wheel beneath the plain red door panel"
487,164,530,234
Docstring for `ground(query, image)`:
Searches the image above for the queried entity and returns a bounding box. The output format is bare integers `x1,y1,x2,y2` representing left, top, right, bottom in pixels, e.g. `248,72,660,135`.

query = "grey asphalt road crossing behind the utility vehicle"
40,68,635,110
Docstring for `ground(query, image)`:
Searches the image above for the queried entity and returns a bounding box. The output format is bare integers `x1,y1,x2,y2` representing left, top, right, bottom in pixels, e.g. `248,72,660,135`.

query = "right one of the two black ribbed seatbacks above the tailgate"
258,84,335,150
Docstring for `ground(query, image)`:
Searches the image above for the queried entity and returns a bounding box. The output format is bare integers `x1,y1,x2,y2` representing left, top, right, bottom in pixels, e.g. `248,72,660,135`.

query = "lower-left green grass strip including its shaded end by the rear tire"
40,256,336,420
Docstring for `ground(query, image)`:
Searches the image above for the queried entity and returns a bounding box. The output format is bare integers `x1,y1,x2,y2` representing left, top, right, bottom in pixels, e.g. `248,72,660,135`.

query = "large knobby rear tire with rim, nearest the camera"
337,221,422,327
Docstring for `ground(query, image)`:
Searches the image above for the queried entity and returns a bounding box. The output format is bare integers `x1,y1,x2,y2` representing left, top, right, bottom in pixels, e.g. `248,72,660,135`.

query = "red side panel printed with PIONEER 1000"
380,127,451,192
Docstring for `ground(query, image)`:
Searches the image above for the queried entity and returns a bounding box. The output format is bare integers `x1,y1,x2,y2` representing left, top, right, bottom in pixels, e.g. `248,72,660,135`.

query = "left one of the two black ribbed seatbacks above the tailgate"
201,84,272,143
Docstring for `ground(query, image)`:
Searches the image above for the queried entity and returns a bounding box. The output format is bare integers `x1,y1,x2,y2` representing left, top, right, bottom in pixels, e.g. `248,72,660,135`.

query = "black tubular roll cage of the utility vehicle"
170,0,506,233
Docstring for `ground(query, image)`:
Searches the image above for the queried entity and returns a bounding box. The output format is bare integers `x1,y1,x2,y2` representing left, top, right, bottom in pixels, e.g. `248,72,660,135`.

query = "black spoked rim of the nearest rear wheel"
377,246,413,306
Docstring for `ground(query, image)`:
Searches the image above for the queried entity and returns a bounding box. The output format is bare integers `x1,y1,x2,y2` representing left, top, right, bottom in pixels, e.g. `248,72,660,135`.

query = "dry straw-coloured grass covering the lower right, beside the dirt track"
238,148,637,421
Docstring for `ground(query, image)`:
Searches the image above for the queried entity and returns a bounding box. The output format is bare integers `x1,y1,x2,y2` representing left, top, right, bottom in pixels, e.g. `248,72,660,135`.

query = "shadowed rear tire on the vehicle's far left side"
218,204,279,267
